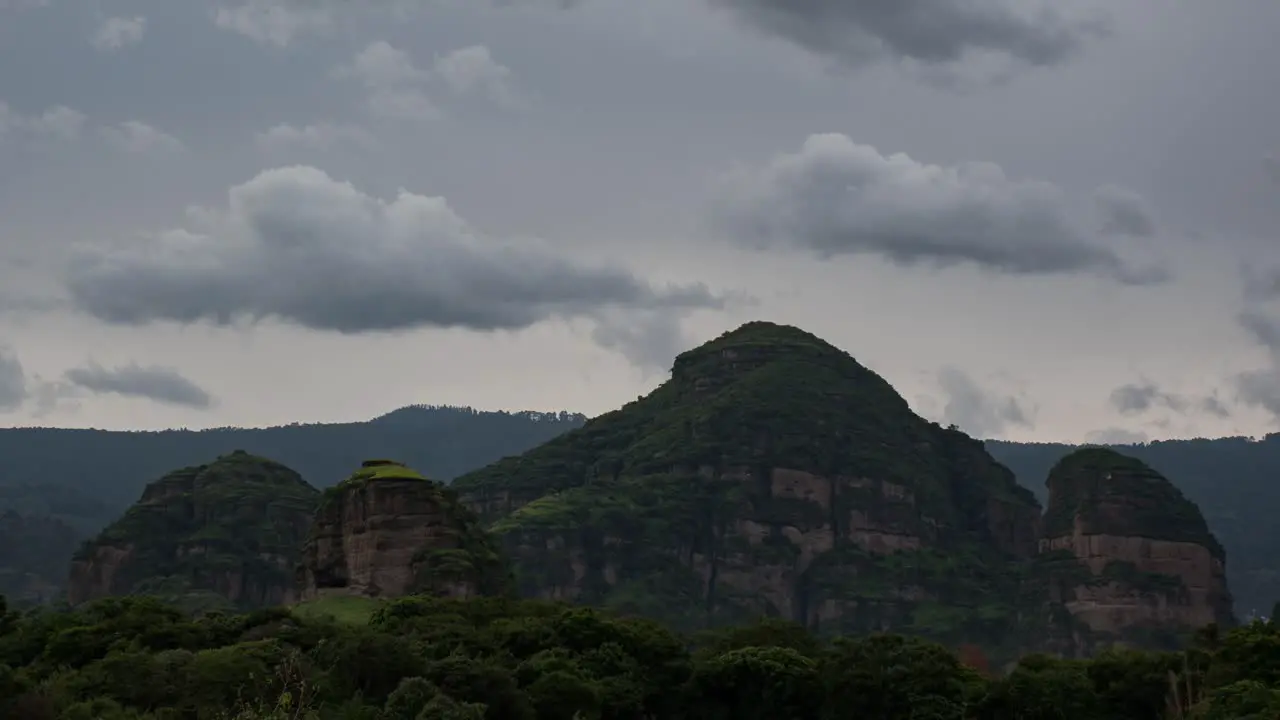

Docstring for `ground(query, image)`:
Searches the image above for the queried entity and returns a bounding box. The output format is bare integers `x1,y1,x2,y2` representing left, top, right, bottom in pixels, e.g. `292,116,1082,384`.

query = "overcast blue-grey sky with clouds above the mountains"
0,0,1280,442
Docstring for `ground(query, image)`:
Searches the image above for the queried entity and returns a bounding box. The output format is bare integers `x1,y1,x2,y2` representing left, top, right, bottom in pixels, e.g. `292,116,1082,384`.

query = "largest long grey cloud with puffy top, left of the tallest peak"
67,167,722,353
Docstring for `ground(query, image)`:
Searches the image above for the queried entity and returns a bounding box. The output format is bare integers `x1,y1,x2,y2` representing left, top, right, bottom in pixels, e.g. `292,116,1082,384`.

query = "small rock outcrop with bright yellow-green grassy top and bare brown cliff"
298,460,508,600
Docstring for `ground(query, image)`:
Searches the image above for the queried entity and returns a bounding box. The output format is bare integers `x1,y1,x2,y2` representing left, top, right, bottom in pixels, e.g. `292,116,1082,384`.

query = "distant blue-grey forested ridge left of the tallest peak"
0,405,586,514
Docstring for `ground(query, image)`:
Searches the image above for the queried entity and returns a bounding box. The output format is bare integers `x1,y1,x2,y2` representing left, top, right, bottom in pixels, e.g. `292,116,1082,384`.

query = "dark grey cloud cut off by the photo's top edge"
710,0,1107,67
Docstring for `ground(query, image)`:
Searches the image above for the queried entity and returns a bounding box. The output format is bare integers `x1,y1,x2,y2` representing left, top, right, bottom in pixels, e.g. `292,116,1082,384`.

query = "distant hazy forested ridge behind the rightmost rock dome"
986,433,1280,616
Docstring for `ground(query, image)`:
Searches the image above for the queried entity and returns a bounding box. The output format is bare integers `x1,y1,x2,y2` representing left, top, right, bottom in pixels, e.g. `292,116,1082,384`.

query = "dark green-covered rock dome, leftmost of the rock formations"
67,451,320,609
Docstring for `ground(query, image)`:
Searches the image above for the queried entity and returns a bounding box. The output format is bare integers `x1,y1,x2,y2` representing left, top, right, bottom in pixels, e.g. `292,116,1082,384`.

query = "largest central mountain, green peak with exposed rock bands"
453,323,1039,647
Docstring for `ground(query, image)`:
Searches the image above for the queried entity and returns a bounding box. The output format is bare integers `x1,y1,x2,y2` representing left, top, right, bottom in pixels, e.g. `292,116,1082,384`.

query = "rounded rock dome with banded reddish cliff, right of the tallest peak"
1041,448,1234,653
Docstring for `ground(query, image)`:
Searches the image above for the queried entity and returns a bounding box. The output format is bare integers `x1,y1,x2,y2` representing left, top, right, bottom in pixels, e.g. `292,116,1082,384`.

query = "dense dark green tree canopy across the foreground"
0,597,1280,720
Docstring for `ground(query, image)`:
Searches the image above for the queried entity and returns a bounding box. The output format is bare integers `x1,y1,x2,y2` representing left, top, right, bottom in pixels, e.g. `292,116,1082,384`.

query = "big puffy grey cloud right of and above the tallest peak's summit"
716,133,1166,284
